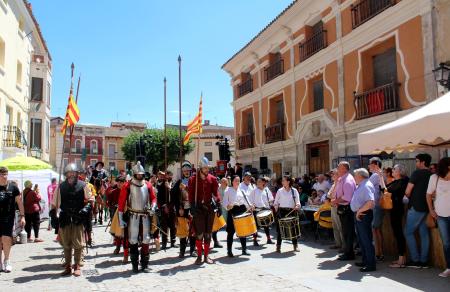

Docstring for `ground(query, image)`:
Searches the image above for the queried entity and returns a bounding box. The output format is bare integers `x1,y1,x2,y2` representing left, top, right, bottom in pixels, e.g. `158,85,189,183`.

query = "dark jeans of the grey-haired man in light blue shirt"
355,210,376,268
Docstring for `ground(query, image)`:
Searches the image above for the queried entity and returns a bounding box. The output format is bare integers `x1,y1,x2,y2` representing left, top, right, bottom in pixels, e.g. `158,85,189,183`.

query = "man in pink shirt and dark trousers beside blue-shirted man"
331,161,356,261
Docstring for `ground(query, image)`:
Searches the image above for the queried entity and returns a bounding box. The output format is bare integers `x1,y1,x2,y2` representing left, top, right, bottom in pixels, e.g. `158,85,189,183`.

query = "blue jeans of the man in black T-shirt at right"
405,207,430,263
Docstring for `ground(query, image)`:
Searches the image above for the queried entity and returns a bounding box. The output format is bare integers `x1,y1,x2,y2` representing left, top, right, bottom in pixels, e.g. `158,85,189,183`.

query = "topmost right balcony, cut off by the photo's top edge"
351,0,397,29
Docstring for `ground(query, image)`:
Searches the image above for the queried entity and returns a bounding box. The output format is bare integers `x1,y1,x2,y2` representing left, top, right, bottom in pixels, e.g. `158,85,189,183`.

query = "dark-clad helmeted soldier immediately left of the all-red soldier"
170,161,195,258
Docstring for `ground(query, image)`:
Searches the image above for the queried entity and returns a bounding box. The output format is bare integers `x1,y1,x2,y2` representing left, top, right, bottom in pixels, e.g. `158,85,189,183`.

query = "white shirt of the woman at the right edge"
427,174,450,217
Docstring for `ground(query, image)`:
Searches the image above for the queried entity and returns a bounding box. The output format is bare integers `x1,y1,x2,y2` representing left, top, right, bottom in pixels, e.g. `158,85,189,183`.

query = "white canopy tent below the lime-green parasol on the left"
8,169,59,218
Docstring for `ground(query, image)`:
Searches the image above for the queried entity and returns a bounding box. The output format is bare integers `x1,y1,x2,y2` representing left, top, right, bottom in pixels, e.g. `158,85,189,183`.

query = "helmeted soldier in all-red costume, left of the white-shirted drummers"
188,157,221,265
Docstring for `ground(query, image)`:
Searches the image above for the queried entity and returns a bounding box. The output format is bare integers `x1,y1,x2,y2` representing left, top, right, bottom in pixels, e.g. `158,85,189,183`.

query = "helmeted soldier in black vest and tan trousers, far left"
50,163,92,277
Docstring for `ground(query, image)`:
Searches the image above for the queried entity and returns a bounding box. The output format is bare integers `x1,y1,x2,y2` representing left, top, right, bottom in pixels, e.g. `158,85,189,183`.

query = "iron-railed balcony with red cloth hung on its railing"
353,81,401,120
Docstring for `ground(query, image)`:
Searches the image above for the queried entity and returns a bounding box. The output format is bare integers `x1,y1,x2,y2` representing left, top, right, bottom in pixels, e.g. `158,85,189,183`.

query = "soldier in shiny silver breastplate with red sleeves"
118,161,156,273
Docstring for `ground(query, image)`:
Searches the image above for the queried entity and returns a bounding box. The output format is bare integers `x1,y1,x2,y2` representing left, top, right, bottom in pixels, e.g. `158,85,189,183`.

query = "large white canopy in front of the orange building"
358,92,450,154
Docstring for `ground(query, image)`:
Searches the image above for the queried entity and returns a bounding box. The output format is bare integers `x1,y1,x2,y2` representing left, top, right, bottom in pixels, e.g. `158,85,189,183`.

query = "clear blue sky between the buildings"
30,0,291,127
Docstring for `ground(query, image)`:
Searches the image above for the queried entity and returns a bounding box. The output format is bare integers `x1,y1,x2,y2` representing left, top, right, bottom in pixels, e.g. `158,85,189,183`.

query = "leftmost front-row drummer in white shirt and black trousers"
223,175,252,257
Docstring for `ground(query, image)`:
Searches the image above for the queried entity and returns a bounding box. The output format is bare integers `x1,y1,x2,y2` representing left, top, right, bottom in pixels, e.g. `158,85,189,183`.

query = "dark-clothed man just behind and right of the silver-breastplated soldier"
156,171,176,250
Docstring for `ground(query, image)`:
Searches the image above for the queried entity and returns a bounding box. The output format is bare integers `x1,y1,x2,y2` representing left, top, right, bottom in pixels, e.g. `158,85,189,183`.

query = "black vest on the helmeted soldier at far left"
60,180,85,217
